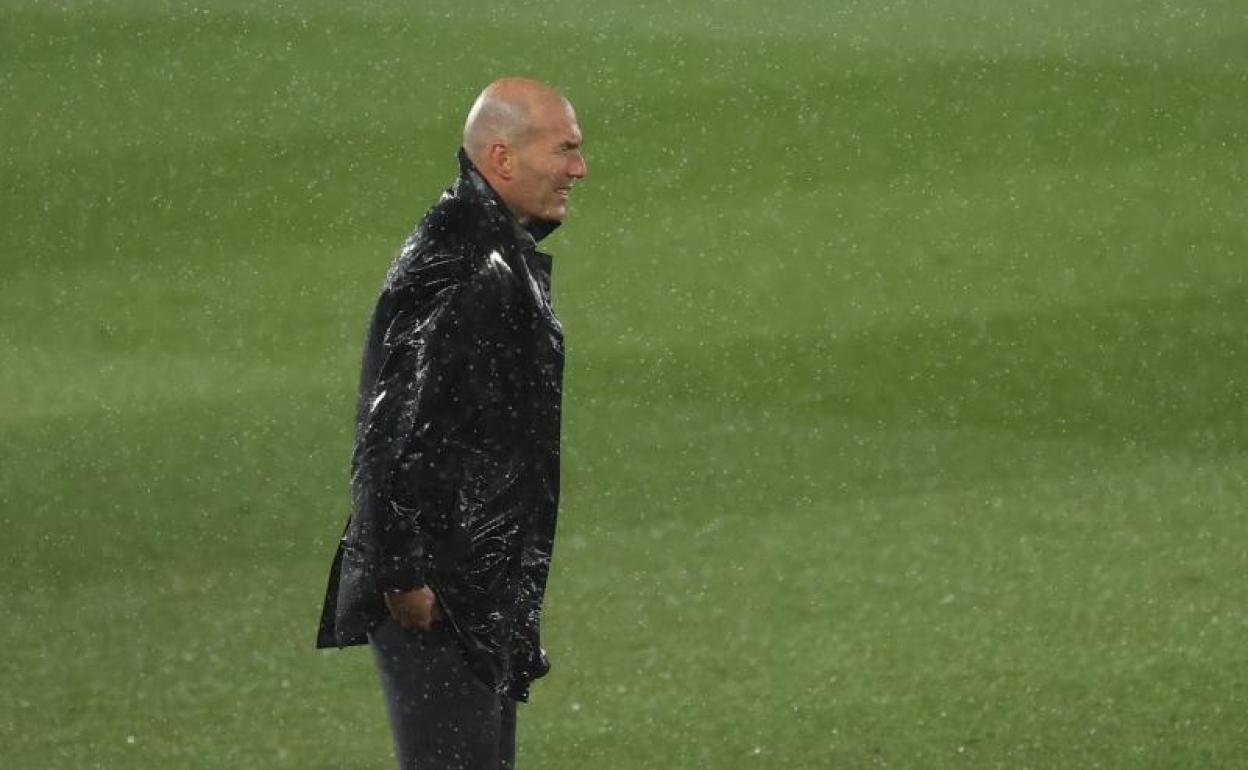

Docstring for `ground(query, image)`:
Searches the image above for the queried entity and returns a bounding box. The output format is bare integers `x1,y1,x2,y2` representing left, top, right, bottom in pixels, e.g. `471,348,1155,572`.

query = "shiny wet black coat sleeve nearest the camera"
356,256,490,592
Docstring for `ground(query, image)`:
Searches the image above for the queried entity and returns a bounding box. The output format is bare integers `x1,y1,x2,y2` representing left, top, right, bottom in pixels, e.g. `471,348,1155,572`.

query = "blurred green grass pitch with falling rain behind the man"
0,0,1248,770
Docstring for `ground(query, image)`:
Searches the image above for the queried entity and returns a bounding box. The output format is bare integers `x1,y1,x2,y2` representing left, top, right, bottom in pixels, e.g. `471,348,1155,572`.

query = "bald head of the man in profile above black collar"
463,77,587,223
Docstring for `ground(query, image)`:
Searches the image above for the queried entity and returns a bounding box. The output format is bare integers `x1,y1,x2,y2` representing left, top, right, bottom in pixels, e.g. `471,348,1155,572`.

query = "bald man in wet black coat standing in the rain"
317,77,587,770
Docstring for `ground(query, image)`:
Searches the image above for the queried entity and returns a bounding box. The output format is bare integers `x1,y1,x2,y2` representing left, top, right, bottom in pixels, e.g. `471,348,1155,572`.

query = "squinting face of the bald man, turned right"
507,100,588,222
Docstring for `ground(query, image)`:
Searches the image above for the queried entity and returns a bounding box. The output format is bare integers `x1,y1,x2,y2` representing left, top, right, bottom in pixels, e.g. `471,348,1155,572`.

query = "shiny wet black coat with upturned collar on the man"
317,150,563,700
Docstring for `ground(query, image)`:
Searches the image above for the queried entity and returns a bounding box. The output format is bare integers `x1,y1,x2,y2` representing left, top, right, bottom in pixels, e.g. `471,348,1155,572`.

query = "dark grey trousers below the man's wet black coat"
368,618,515,770
